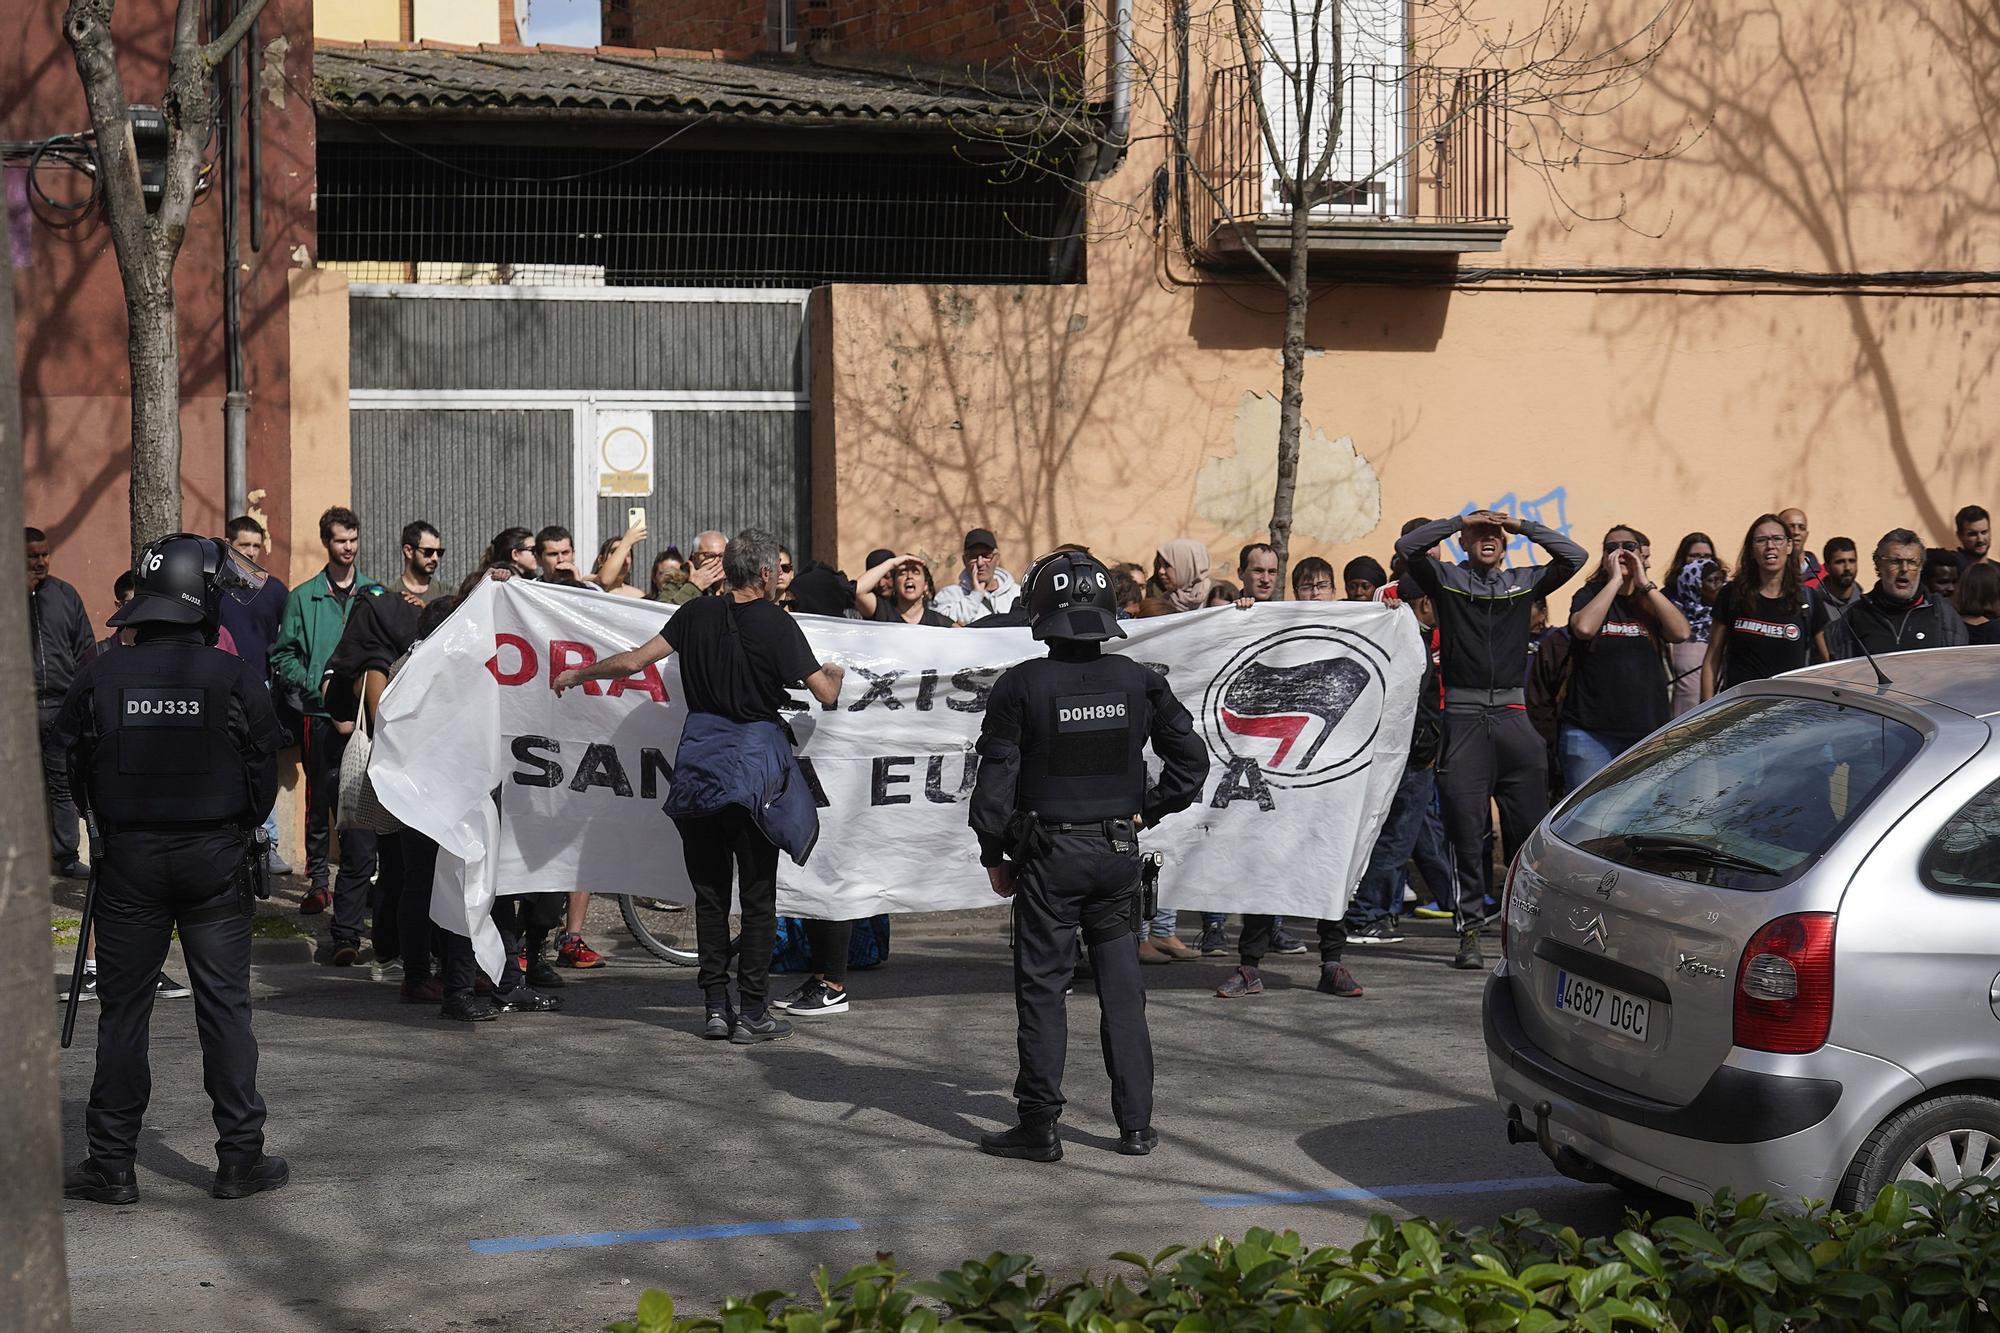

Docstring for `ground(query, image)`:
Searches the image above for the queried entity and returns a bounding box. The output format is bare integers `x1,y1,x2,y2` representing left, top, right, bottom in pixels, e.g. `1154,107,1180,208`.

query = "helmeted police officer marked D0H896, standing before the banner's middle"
972,550,1208,1161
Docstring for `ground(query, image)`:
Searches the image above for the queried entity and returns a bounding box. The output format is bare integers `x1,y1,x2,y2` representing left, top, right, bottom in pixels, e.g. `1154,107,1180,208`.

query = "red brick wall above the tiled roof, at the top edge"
624,0,1062,64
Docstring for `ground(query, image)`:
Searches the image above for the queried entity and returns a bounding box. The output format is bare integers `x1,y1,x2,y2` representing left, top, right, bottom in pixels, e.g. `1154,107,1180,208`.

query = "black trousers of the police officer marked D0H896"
1014,829,1152,1131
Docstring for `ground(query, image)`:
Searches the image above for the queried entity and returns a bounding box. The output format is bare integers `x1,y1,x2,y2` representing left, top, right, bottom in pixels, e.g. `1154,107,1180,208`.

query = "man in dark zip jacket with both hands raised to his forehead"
1396,510,1588,971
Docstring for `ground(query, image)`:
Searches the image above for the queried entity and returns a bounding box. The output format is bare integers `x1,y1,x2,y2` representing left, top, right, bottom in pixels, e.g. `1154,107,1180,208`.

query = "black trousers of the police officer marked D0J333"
84,831,264,1165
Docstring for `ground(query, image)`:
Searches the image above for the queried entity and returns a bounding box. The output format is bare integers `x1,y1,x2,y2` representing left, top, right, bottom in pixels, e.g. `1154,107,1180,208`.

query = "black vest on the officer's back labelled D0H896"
1014,654,1152,821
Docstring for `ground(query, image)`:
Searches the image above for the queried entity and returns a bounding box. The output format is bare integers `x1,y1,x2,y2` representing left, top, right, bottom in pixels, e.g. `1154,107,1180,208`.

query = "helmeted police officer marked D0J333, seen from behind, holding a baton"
56,532,288,1203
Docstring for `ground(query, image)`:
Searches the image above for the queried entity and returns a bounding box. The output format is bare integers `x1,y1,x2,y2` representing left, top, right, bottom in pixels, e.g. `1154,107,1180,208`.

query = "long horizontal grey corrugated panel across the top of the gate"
348,296,806,394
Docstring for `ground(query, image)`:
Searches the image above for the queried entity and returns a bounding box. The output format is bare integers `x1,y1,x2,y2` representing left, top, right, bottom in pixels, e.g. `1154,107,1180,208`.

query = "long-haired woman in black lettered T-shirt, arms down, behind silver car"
1702,514,1826,701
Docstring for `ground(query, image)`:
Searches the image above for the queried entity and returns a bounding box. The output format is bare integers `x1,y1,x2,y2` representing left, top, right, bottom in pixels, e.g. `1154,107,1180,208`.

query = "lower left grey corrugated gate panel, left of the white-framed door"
348,408,576,586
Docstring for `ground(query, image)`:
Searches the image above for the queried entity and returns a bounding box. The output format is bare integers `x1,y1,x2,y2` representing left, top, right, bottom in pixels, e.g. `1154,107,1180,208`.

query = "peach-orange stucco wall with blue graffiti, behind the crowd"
818,0,2000,572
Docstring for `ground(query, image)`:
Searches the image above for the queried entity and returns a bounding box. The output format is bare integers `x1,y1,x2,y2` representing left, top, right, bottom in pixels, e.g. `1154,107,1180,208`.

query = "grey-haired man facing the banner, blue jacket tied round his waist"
552,528,846,1047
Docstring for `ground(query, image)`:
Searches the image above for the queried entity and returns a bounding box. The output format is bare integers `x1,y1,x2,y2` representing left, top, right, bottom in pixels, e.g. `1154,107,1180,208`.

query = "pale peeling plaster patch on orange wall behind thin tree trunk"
1194,392,1382,548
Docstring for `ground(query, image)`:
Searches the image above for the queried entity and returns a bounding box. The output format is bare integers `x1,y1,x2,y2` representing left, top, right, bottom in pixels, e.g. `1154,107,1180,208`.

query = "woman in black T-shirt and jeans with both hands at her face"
1556,526,1688,791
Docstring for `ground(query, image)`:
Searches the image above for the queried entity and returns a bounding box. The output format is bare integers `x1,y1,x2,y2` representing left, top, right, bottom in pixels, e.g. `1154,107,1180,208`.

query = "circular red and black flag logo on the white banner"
1202,626,1390,787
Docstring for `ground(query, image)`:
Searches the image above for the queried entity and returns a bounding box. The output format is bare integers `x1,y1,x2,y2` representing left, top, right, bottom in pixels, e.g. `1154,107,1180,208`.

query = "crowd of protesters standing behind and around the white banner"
26,504,2000,1041
